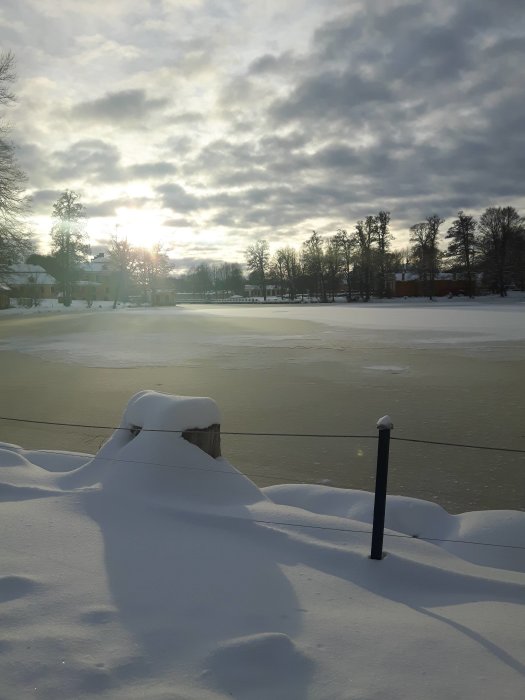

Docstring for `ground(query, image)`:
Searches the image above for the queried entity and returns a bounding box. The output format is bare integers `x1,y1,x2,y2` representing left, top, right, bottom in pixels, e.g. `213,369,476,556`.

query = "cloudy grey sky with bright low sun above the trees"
0,0,525,267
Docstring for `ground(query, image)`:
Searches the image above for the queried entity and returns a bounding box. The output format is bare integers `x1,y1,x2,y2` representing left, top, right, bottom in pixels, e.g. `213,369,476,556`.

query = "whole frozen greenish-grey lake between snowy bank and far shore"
0,300,525,512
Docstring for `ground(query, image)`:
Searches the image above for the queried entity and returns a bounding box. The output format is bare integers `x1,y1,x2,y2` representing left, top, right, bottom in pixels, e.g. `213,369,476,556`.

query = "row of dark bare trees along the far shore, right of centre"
178,207,525,302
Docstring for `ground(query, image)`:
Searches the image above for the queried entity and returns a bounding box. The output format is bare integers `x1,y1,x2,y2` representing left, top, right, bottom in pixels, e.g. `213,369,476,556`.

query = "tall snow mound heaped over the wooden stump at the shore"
60,391,266,507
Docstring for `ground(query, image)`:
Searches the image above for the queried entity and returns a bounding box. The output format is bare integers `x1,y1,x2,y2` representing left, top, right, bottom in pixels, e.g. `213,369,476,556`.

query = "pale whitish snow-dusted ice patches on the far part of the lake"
1,302,525,372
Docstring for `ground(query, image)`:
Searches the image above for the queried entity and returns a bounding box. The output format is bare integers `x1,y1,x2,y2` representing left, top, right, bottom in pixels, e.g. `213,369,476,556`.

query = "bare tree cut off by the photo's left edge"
0,52,34,277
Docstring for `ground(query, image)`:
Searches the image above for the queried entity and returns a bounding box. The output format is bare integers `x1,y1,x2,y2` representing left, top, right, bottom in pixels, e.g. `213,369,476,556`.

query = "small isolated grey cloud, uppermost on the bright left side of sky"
71,89,168,126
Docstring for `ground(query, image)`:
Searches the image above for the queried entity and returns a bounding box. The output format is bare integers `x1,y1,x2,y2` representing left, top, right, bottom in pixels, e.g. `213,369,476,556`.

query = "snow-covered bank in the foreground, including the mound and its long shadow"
0,392,525,700
